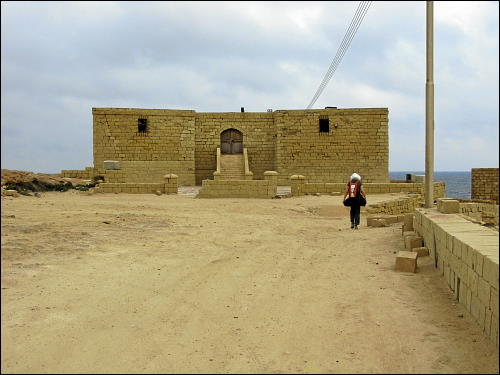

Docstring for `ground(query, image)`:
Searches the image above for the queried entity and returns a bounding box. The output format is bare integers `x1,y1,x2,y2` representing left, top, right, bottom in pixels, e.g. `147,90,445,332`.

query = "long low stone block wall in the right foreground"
413,208,499,347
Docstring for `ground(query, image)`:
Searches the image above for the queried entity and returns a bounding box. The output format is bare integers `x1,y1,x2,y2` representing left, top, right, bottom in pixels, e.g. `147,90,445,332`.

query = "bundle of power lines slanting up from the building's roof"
307,1,372,109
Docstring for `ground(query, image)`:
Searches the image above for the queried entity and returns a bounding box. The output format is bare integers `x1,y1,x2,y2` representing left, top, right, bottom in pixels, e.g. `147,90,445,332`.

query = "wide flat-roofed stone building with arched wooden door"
63,107,389,185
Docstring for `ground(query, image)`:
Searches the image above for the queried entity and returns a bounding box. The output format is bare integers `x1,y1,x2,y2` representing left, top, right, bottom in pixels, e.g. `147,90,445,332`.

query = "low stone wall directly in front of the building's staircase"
198,171,278,198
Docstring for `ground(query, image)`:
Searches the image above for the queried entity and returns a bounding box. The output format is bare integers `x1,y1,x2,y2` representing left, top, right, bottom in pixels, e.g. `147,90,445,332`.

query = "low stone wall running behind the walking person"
290,175,445,199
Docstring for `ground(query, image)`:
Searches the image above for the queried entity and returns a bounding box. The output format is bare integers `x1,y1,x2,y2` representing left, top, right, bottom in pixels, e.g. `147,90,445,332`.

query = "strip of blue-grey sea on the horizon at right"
389,171,471,199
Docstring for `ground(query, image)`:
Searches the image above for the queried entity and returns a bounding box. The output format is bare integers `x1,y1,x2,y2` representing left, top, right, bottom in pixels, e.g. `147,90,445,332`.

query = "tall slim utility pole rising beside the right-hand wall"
425,1,434,208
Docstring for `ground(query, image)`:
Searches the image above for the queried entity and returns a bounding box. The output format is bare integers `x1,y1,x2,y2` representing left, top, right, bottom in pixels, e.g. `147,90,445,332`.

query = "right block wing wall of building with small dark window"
274,108,389,184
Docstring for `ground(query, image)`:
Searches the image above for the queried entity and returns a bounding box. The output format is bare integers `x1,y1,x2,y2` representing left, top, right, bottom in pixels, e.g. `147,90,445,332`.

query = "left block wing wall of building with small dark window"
92,108,195,185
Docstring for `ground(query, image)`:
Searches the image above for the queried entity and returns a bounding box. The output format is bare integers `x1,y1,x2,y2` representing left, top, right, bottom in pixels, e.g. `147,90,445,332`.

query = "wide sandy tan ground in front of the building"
1,191,499,373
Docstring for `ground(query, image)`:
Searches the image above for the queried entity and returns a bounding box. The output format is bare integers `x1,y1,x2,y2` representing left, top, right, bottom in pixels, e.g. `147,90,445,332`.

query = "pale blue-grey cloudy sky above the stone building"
1,1,499,173
